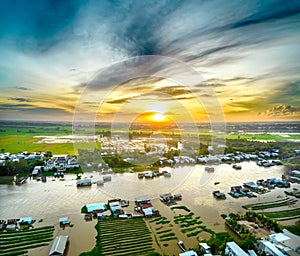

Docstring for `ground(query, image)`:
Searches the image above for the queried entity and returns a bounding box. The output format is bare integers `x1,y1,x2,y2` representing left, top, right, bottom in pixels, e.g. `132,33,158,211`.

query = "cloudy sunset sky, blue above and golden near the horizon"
0,0,300,122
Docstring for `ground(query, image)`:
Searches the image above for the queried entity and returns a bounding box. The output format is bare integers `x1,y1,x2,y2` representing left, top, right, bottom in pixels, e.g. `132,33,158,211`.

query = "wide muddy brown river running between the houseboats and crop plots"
0,162,299,256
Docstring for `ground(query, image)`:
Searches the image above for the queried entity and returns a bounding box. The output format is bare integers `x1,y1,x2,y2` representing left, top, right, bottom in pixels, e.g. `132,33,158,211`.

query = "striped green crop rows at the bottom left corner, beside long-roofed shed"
0,226,54,256
